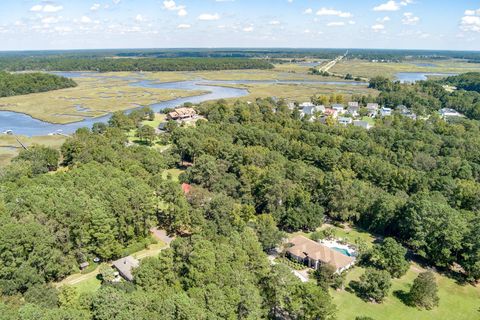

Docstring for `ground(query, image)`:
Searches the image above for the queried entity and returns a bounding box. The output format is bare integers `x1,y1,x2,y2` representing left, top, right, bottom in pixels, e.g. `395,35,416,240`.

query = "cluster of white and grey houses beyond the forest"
299,101,417,129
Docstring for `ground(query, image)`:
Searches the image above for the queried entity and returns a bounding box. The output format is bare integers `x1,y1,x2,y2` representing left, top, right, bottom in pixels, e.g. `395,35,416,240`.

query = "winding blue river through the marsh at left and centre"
0,72,366,136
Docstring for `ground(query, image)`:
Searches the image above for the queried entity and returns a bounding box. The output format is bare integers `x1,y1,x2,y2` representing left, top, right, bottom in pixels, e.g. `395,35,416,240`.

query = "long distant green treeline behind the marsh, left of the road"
0,57,273,72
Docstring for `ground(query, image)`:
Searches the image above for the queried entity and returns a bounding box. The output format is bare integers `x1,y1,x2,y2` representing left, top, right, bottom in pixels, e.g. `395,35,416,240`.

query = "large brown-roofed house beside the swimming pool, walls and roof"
286,236,355,273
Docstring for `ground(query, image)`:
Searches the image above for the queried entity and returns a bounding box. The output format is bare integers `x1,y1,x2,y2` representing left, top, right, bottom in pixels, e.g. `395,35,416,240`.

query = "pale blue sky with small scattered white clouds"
0,0,480,50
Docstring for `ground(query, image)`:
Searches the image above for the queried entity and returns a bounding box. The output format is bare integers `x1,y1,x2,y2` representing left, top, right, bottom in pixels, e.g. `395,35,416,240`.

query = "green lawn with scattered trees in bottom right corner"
331,265,480,320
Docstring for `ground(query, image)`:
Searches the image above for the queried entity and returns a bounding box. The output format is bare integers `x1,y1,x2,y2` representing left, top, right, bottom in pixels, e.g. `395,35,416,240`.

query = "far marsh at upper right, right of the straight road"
330,60,480,79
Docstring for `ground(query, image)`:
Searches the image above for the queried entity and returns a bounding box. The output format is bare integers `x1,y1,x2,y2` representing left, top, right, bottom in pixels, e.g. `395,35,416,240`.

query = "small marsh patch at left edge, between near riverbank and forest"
0,134,67,168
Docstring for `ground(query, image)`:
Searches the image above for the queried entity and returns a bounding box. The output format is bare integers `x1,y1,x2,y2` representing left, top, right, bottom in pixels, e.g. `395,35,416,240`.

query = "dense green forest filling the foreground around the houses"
0,85,480,320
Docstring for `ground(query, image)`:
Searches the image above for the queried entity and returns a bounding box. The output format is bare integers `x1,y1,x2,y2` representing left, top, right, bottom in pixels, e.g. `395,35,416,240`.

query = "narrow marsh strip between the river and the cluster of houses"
215,83,378,101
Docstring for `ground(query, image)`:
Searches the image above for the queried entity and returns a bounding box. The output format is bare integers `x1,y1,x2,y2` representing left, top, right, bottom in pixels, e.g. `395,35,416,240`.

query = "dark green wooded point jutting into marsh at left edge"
0,72,77,97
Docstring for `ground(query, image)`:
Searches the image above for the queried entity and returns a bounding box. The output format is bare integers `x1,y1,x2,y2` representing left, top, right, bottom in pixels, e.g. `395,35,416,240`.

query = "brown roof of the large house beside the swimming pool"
287,236,355,270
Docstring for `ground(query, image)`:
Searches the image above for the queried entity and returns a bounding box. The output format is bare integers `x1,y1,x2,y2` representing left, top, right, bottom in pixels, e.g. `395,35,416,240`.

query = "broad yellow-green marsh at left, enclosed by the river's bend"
0,77,203,123
